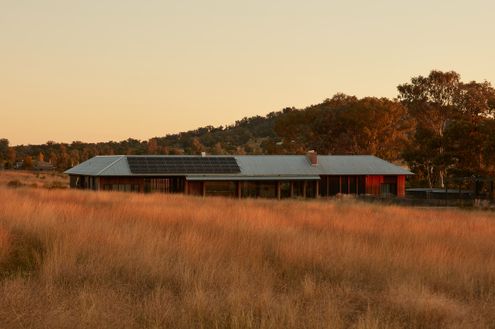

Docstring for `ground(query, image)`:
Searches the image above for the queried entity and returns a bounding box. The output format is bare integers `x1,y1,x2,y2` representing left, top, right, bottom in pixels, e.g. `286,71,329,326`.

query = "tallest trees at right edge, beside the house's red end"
398,71,495,187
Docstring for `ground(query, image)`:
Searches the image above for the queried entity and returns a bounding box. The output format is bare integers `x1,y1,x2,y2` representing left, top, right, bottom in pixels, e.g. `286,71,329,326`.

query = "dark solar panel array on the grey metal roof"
127,156,241,174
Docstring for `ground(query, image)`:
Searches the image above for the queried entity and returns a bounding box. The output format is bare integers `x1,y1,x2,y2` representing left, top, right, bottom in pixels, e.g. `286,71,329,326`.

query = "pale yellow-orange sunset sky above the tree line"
0,0,495,145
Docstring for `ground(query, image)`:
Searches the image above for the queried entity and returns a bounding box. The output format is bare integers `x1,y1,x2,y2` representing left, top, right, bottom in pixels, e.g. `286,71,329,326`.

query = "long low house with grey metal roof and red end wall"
65,151,413,199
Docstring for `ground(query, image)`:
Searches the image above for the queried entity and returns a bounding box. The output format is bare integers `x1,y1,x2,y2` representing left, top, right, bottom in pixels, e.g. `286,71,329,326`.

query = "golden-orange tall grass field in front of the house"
0,172,495,329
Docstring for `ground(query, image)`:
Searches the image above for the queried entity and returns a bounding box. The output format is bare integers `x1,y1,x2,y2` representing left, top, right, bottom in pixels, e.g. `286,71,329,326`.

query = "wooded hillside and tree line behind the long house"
0,71,495,186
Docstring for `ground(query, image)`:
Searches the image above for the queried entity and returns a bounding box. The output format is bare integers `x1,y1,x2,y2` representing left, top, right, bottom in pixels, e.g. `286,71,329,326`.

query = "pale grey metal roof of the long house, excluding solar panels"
65,155,413,180
